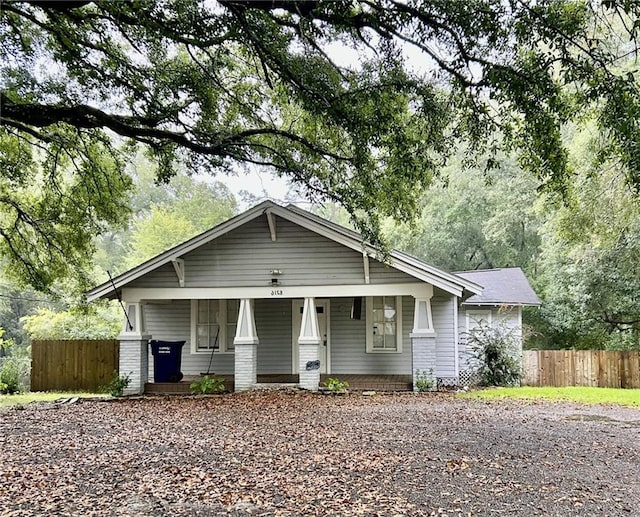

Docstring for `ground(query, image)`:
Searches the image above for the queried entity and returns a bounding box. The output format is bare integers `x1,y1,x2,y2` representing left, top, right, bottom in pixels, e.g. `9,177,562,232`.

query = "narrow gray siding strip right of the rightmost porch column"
431,295,458,378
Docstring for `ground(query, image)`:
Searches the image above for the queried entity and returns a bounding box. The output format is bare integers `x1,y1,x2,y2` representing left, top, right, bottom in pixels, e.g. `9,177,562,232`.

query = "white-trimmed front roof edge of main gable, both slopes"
86,201,482,301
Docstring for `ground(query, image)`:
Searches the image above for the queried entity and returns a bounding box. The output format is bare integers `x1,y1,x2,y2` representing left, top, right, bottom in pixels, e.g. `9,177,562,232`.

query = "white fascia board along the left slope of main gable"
85,201,277,302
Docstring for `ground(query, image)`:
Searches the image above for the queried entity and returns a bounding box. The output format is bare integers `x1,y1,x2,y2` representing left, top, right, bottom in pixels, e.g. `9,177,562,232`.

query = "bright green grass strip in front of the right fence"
458,386,640,407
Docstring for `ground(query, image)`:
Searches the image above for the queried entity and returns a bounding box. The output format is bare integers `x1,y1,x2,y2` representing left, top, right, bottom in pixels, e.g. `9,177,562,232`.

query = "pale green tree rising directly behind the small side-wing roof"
386,155,541,271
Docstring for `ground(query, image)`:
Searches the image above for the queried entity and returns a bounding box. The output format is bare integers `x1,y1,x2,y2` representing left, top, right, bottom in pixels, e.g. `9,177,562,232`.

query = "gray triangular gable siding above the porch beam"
130,216,415,287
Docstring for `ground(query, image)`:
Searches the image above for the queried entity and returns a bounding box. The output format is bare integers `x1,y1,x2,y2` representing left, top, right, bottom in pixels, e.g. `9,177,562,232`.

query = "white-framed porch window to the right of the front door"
366,296,402,353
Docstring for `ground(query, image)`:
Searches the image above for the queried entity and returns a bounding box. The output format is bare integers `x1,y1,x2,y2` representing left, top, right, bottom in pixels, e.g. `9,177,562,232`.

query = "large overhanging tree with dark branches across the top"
0,0,640,287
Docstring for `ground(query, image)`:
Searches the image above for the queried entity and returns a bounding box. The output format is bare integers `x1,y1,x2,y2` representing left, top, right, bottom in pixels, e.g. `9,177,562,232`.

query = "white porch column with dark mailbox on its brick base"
298,298,322,391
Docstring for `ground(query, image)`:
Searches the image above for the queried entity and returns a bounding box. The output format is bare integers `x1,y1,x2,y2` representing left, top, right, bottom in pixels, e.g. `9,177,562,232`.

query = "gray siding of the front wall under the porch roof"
144,293,456,378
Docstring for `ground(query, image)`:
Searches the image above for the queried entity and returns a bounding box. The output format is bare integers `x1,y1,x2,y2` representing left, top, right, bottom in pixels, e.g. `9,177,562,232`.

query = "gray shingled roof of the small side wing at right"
456,267,541,306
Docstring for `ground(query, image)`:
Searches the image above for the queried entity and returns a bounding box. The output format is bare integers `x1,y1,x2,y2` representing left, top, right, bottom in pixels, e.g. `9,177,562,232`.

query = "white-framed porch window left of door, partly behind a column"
191,300,240,353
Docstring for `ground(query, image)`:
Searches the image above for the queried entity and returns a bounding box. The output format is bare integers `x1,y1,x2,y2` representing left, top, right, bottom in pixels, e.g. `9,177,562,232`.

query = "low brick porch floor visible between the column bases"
144,374,413,395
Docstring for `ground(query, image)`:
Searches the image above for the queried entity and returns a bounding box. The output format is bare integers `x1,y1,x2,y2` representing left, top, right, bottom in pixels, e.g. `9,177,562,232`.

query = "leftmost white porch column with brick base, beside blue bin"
118,302,151,395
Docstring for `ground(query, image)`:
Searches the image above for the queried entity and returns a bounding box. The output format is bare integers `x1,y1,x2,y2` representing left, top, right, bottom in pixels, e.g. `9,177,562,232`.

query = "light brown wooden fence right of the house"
522,350,640,388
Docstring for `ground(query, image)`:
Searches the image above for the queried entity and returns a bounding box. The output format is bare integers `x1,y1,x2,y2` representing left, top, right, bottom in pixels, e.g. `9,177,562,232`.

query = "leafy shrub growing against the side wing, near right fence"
468,326,522,386
